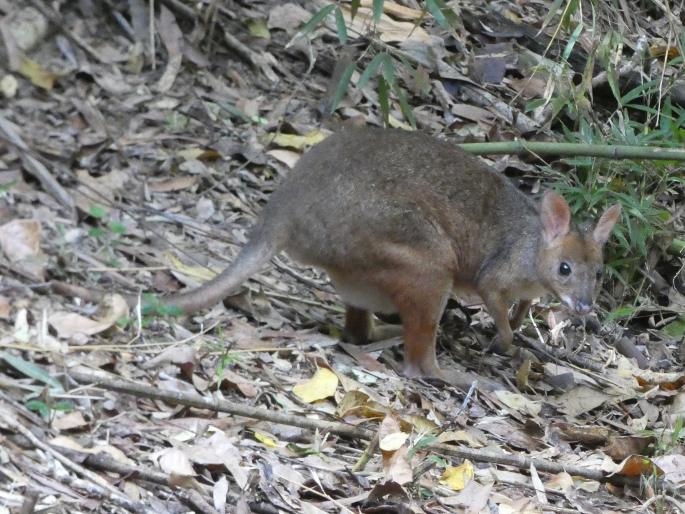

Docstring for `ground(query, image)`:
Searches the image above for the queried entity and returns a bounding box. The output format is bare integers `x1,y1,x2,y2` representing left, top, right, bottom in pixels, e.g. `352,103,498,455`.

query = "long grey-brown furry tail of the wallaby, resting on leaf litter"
160,234,280,314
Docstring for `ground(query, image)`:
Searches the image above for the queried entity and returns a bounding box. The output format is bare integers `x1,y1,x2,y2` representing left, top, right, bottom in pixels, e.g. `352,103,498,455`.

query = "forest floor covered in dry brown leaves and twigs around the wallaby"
0,0,685,513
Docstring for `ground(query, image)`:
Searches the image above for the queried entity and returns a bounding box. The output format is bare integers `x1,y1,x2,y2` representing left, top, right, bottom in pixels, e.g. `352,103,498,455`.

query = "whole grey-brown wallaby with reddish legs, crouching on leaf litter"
144,128,620,376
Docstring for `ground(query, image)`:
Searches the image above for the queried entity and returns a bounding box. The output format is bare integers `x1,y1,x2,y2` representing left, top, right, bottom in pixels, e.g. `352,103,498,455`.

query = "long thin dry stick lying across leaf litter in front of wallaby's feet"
69,368,640,486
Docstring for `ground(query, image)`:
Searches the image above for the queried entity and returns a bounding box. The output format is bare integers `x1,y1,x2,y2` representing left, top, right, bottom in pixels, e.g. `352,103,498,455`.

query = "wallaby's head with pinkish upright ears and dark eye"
537,191,621,314
